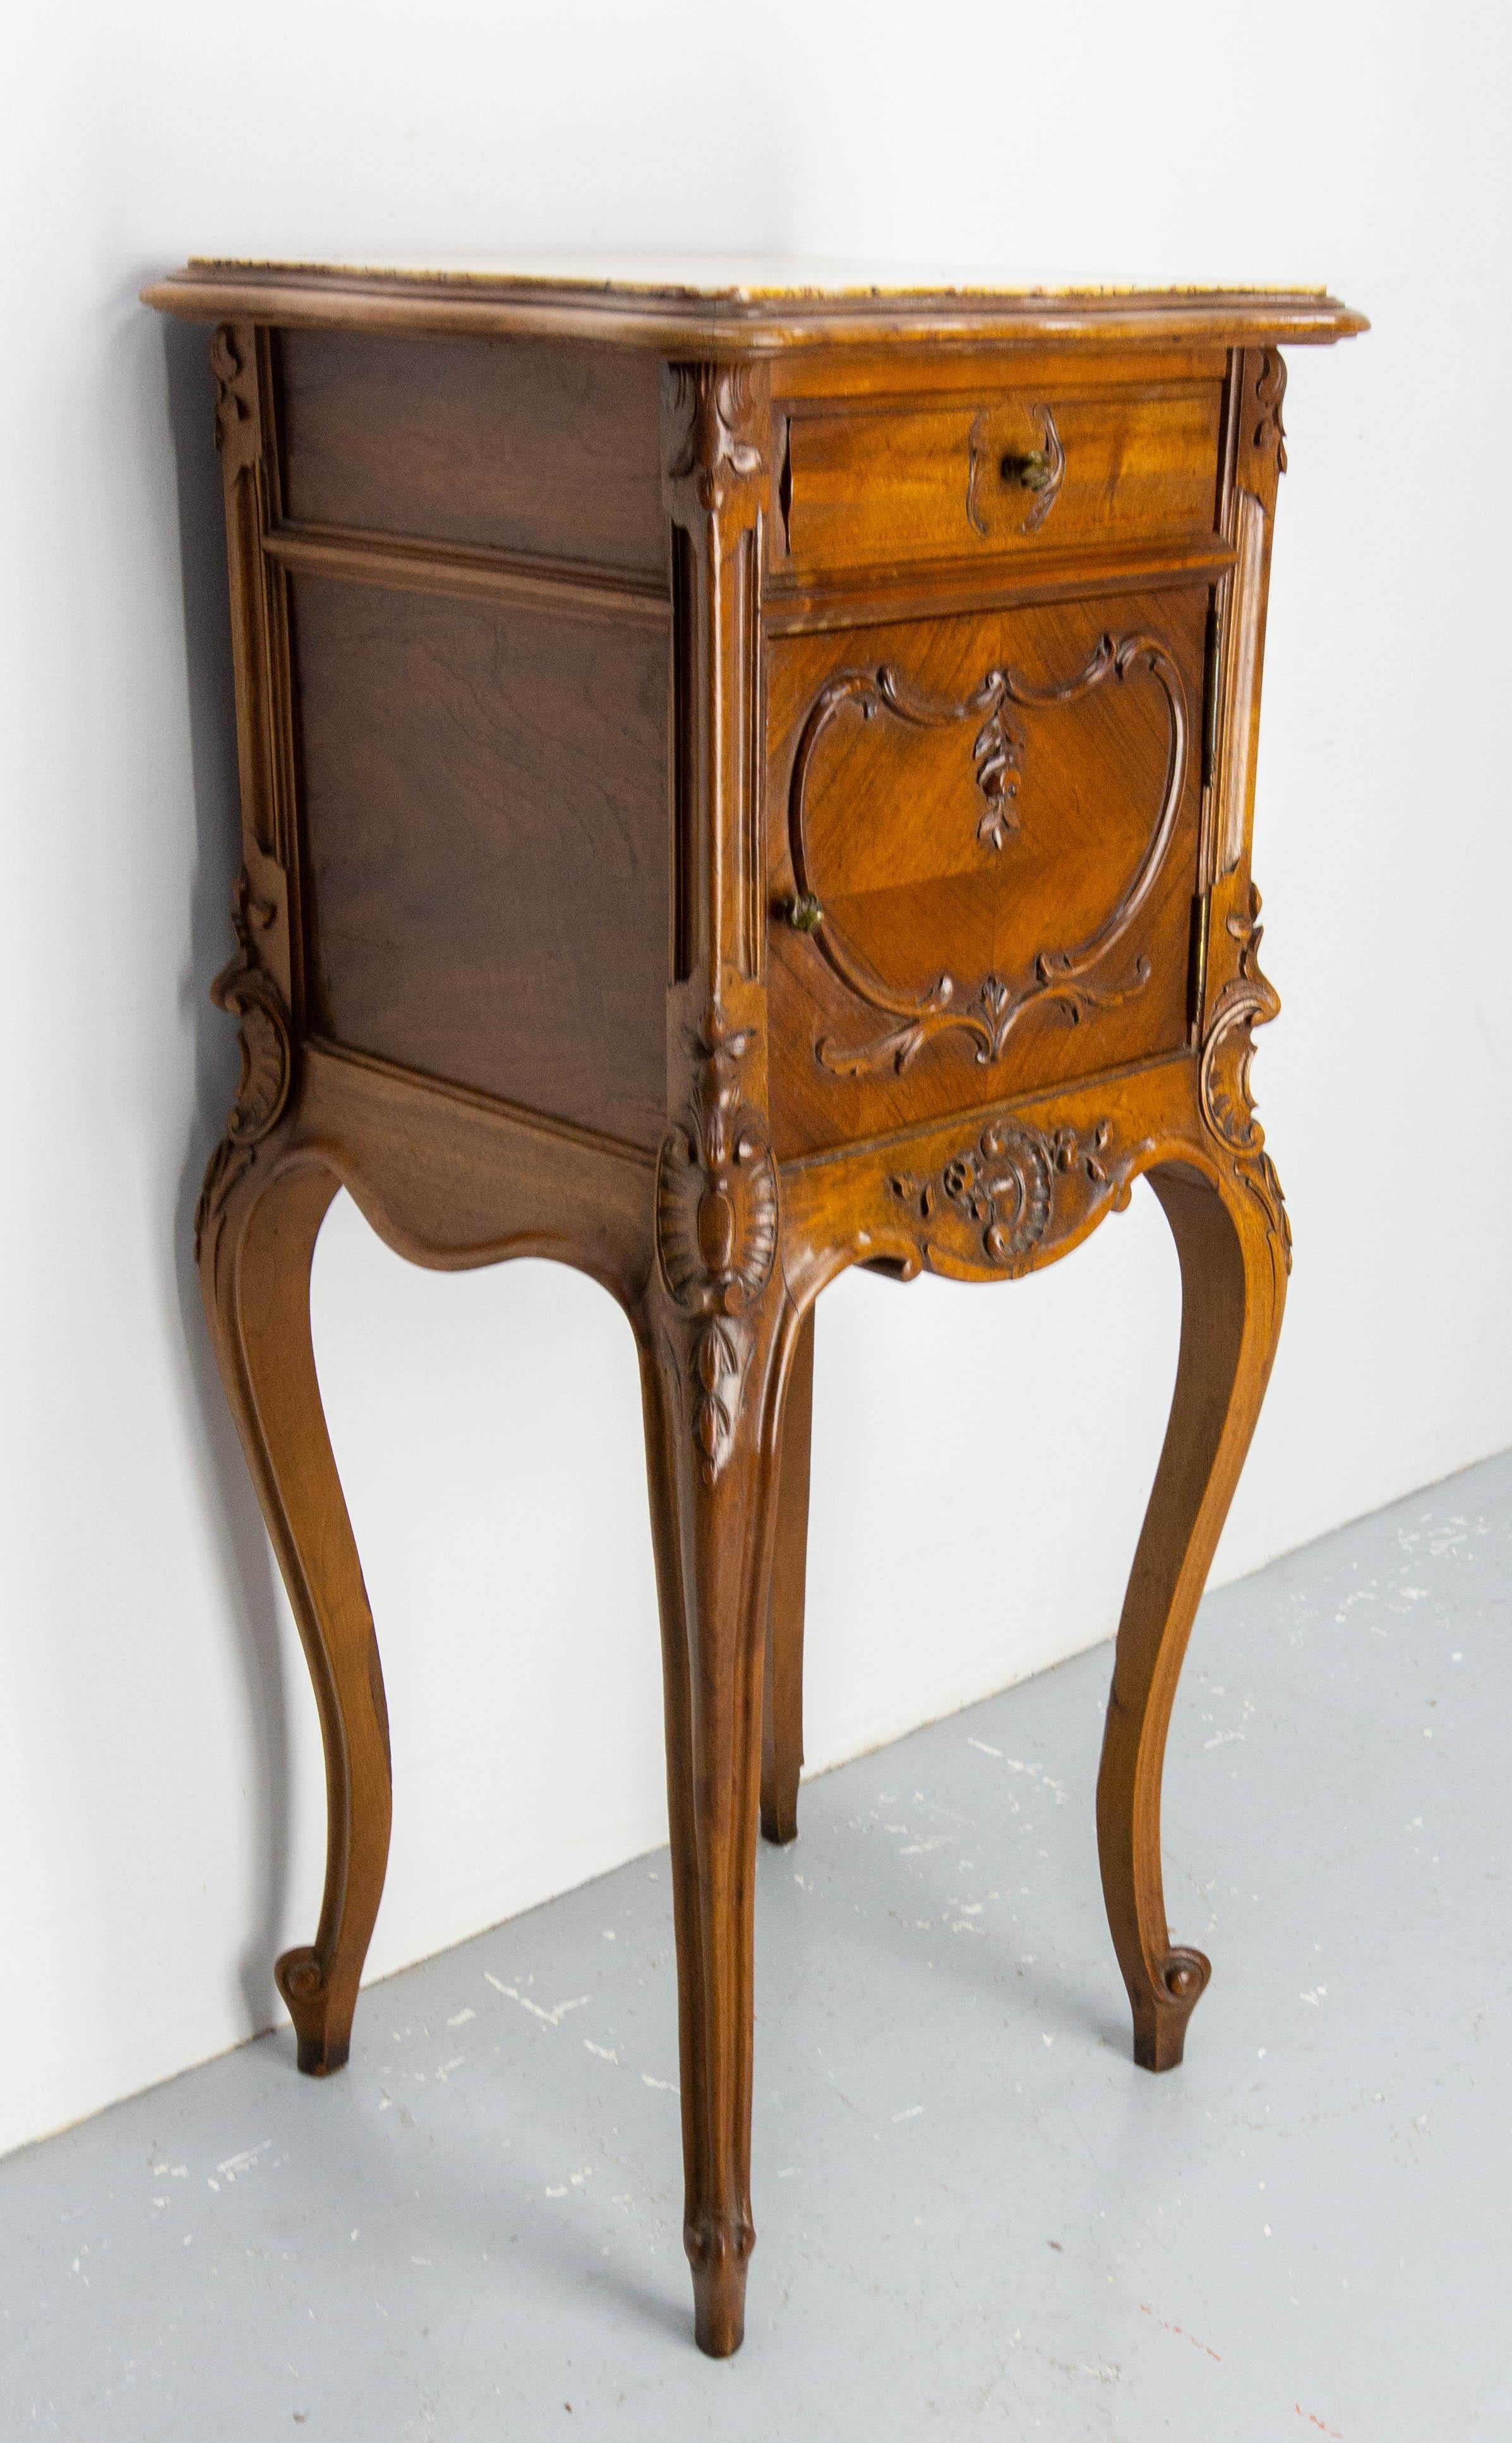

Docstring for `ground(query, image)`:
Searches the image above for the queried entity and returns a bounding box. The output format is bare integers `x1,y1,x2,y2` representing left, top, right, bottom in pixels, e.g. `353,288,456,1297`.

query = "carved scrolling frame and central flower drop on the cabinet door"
786,635,1187,1077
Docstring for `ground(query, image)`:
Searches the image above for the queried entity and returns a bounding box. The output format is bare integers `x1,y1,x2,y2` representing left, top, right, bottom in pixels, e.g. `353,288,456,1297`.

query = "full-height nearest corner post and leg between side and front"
640,364,796,2358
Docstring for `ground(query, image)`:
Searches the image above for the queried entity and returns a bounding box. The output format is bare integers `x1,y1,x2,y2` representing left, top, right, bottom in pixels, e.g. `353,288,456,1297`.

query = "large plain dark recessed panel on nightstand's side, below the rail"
293,577,669,1146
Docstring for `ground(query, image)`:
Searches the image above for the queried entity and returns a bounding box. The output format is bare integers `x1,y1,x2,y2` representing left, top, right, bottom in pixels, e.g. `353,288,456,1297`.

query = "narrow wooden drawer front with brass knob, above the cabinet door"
782,378,1224,574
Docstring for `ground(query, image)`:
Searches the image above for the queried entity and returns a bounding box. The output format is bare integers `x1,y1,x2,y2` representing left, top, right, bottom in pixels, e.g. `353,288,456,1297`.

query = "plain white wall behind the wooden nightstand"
0,0,1512,2142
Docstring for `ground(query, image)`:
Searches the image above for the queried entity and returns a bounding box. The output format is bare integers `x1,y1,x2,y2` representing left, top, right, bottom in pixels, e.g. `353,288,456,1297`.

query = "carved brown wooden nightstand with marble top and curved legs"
147,264,1365,2355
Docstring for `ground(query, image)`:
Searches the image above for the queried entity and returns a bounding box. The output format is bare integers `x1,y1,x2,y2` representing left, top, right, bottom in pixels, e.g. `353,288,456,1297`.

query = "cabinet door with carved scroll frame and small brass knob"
767,584,1209,1155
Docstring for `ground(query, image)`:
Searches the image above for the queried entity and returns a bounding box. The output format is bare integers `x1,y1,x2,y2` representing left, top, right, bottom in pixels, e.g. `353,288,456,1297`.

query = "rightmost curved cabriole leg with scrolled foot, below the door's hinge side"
1097,1167,1285,2069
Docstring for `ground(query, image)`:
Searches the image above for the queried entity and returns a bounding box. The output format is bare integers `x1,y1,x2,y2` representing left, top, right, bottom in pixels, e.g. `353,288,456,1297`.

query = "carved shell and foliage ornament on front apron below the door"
887,1119,1129,1276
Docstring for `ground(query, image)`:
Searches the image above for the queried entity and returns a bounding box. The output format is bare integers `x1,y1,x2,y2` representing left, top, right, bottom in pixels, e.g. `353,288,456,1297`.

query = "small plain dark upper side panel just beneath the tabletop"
279,330,667,572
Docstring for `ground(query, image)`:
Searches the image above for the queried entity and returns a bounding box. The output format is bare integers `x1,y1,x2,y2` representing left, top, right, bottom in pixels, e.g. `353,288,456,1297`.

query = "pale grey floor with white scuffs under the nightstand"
0,1456,1512,2443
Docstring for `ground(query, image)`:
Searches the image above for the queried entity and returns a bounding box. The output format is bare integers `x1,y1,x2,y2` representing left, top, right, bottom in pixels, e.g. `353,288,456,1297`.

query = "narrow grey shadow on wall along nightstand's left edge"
161,320,291,2032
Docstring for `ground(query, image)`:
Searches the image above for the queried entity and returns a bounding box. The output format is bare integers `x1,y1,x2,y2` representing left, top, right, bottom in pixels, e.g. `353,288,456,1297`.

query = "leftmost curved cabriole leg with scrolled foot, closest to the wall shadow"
198,1141,391,2077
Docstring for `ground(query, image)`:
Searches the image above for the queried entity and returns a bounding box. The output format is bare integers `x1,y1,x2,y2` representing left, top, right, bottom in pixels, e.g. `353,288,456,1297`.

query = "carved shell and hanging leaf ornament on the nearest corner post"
657,1009,777,1485
